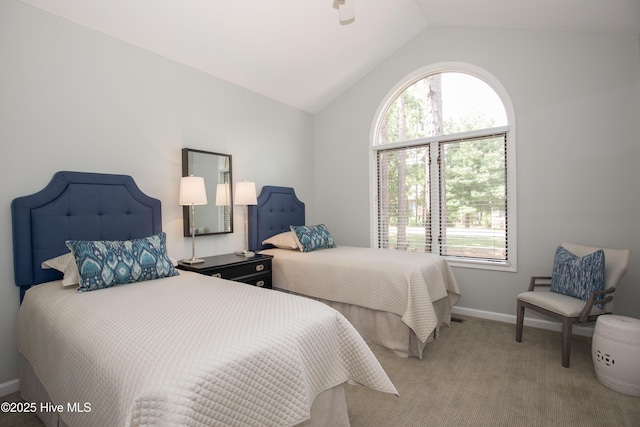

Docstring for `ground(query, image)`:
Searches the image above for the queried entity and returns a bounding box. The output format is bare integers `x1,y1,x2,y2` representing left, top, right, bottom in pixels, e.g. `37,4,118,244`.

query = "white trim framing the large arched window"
369,62,518,272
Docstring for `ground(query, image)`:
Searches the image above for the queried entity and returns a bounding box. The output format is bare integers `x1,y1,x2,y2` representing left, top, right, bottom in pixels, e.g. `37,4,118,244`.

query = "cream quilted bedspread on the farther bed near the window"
262,246,460,343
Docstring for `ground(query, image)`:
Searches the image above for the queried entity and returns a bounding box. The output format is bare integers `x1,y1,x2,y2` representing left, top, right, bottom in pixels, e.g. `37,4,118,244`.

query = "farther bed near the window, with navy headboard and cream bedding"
249,186,460,358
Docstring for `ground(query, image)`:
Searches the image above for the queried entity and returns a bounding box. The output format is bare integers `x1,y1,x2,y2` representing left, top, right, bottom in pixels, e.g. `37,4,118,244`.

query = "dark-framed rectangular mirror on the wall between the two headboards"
182,148,233,237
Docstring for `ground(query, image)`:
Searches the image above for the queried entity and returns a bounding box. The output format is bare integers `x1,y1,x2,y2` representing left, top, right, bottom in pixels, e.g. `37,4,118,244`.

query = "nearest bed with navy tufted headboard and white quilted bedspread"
12,172,397,426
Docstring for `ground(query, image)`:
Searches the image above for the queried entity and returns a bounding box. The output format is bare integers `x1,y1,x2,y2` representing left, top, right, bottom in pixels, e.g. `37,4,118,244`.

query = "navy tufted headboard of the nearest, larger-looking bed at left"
11,172,162,300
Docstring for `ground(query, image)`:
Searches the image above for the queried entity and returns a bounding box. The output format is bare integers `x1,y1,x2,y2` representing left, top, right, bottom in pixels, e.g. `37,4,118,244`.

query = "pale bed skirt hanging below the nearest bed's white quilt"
19,354,349,427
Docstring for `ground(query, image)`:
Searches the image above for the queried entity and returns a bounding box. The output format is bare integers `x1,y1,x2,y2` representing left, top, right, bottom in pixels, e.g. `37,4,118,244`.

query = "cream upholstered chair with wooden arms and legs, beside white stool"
516,243,631,368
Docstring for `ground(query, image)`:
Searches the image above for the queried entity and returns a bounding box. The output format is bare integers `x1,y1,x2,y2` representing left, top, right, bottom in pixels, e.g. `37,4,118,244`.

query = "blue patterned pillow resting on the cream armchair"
551,246,604,301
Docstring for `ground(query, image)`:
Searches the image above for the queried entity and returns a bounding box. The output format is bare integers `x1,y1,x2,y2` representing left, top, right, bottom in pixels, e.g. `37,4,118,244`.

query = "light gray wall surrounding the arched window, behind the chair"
315,27,640,317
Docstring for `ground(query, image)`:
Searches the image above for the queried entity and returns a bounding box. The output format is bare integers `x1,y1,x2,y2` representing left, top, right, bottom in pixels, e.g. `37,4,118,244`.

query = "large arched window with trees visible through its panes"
372,66,515,270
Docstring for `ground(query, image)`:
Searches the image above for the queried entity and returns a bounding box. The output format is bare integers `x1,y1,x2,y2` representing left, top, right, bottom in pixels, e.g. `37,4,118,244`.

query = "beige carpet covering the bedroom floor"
0,317,640,427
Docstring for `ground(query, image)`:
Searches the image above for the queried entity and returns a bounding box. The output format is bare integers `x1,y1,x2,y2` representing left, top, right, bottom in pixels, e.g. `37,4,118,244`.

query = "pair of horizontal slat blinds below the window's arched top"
376,132,508,262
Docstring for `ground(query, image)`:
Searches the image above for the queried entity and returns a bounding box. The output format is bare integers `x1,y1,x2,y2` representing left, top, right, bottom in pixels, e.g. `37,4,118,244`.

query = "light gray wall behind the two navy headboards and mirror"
0,0,314,385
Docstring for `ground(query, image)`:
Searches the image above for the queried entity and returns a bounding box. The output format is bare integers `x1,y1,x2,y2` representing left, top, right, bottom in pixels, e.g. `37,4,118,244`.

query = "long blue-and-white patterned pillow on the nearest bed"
65,233,179,292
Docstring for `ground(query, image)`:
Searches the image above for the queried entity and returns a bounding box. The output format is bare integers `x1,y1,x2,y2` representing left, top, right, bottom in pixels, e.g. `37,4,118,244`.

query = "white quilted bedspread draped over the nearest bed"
18,272,397,426
